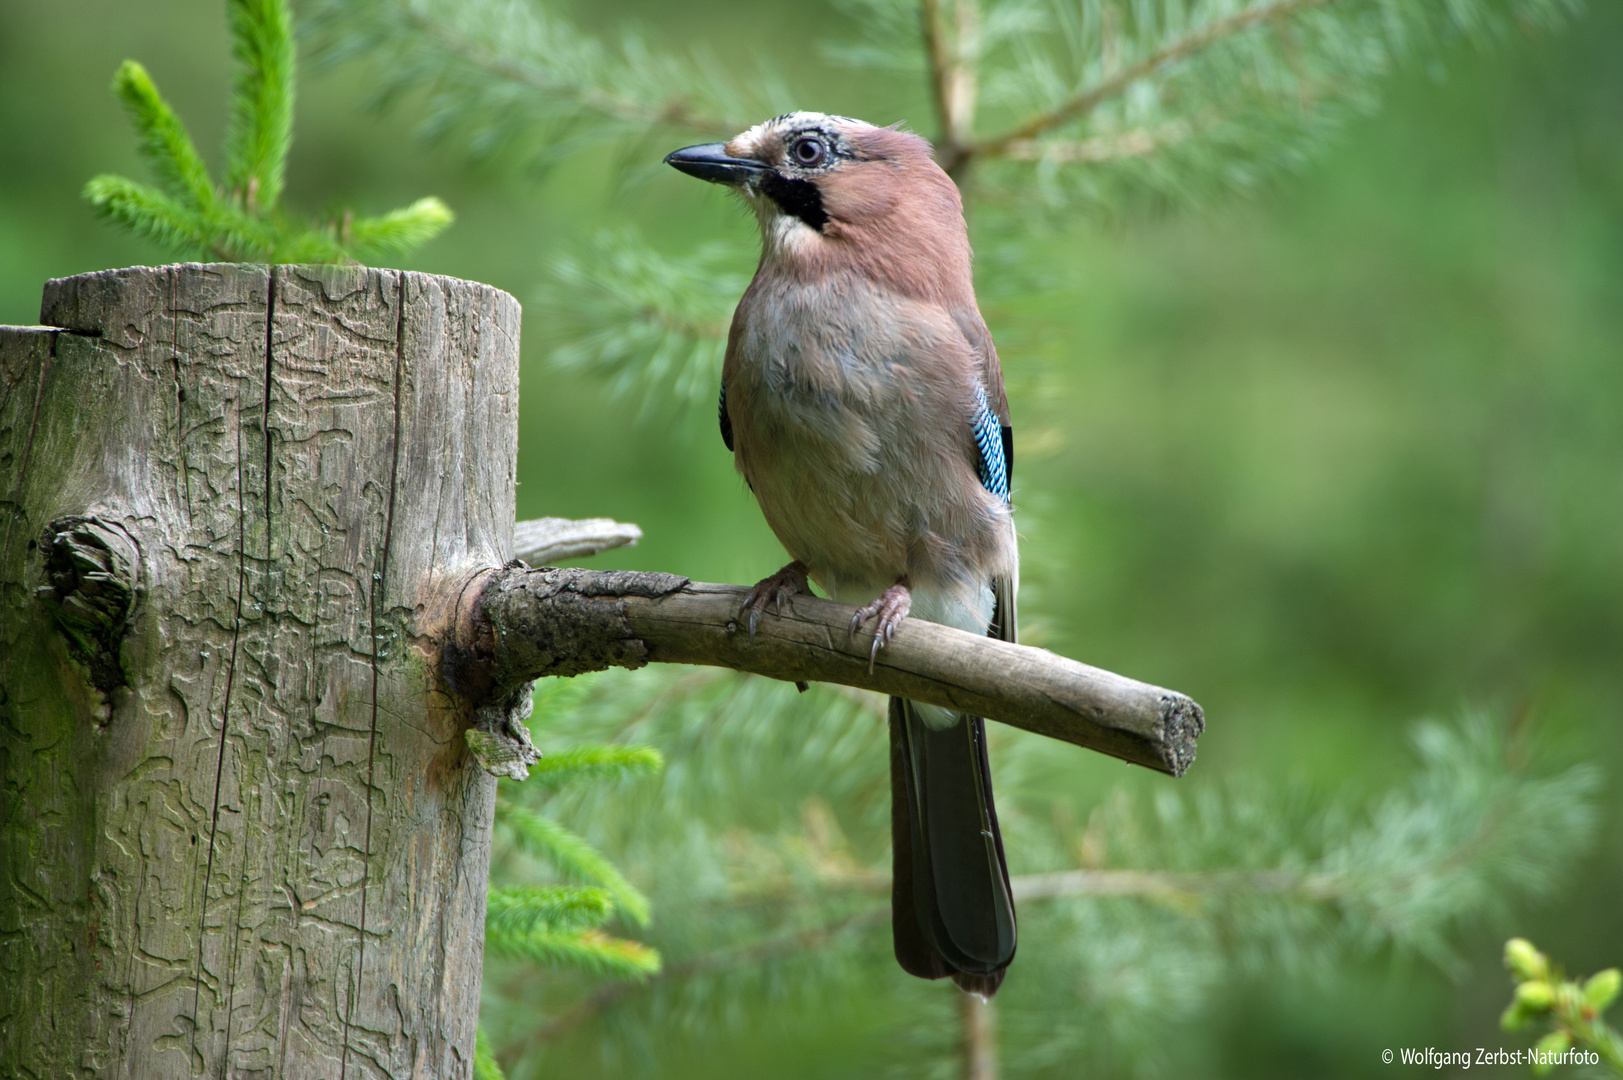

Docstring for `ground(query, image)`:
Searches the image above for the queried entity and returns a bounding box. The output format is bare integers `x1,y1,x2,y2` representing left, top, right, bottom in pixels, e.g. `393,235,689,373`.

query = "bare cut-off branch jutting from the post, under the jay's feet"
446,568,1204,776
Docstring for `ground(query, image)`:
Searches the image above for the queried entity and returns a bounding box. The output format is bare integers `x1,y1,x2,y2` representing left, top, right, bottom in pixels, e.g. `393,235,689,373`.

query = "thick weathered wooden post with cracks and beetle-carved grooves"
0,265,519,1080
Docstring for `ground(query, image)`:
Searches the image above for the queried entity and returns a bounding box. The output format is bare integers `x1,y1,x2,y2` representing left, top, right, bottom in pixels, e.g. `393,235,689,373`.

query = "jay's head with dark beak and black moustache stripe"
665,112,969,284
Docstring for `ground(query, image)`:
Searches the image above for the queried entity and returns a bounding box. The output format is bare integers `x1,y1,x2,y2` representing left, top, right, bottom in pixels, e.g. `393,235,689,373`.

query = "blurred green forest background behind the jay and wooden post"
0,0,1623,1077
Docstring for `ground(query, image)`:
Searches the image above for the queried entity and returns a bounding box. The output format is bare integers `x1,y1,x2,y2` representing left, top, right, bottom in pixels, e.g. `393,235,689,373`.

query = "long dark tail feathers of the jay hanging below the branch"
891,697,1014,997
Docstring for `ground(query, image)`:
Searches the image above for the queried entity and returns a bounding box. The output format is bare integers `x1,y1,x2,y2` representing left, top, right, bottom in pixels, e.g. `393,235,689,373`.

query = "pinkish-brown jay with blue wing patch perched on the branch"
665,112,1019,997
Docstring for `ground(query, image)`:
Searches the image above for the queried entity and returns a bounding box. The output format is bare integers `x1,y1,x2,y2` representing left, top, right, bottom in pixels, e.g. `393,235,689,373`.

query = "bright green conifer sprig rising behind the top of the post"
84,0,451,263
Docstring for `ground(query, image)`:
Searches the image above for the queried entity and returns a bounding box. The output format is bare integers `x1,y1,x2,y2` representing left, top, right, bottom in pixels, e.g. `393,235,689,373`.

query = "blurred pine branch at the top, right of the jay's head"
850,0,1579,205
